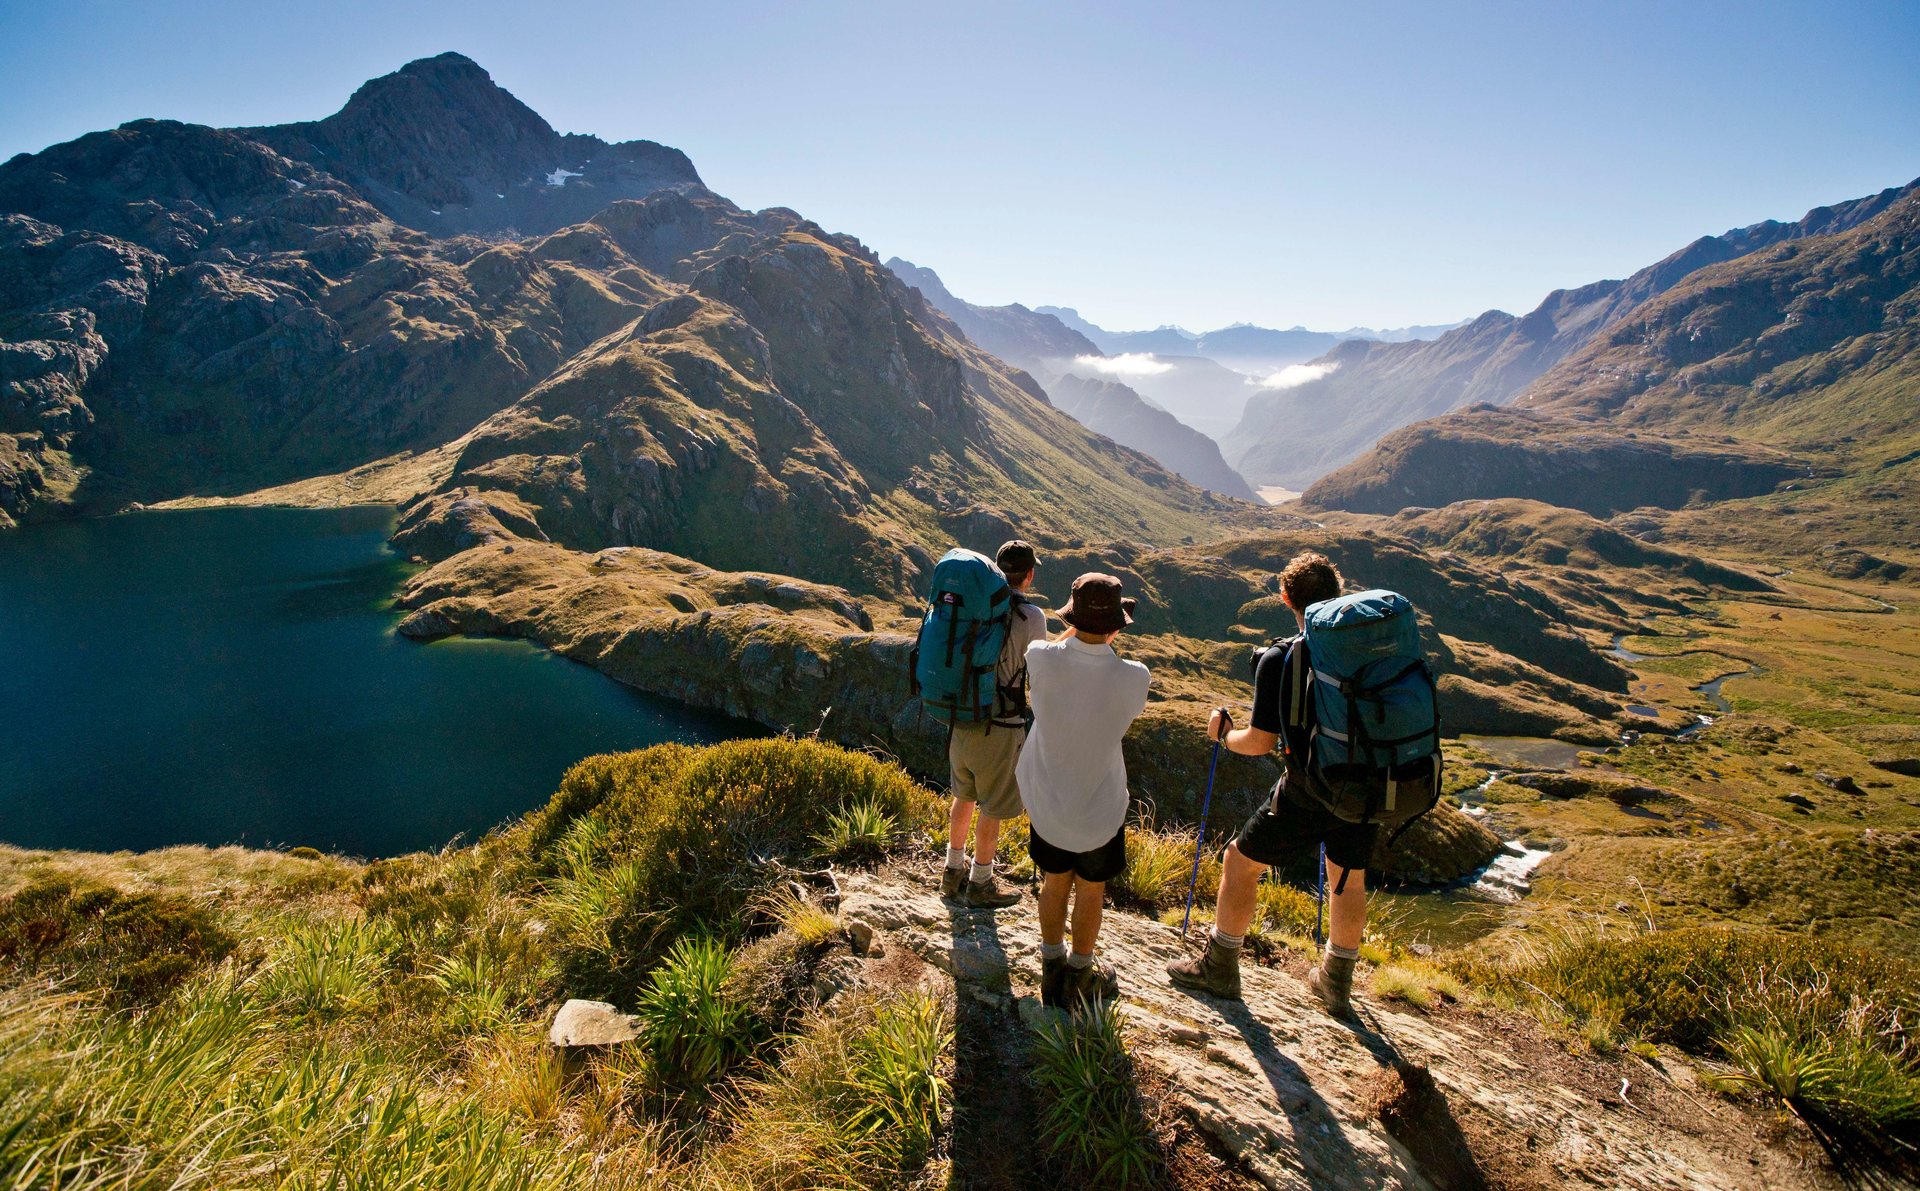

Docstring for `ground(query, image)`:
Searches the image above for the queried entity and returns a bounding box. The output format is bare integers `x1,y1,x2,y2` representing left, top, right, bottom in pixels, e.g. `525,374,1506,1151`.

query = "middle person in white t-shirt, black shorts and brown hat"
1018,572,1148,1009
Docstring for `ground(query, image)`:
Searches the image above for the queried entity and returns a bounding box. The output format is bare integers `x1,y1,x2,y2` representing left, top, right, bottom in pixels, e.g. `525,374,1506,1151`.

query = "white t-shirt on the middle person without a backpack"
1014,638,1148,851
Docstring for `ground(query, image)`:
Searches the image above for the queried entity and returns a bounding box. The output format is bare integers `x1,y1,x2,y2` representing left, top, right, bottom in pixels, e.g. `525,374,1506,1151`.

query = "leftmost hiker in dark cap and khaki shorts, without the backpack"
941,538,1046,909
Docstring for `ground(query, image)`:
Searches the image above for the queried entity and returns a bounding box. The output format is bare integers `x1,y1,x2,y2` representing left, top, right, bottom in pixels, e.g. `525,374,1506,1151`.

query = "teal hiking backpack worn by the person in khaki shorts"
912,547,1014,724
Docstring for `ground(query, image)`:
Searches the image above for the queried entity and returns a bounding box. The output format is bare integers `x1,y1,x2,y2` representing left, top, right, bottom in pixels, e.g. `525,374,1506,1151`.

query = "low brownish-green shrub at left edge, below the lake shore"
0,876,238,1005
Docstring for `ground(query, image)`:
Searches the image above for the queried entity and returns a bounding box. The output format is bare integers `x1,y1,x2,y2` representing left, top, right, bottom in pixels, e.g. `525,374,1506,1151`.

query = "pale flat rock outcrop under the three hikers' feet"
841,872,1826,1191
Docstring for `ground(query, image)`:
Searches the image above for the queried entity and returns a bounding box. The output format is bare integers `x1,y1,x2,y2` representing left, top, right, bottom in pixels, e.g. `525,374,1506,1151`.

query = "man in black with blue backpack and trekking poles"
1167,551,1440,1018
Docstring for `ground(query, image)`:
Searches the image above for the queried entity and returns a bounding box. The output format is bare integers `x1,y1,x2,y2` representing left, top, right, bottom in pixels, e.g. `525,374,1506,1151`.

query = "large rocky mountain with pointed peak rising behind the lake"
0,54,1238,592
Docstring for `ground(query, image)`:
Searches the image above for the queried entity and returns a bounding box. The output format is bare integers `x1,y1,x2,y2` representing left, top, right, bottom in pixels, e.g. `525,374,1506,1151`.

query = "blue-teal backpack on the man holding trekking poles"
1283,590,1442,843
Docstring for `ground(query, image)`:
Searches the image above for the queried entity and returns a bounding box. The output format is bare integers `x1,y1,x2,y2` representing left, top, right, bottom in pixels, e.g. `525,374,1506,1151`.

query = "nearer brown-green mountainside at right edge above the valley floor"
1304,182,1920,578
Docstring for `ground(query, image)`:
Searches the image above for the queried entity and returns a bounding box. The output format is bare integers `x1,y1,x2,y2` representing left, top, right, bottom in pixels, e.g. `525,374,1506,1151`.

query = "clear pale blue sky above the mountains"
0,0,1920,328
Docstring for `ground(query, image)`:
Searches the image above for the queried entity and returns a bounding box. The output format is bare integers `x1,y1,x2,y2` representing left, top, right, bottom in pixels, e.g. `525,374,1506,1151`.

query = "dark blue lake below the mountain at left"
0,507,755,857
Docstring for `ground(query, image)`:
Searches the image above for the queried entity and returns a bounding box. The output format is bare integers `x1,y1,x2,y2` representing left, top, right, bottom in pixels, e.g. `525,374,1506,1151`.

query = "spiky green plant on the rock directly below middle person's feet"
1033,1003,1160,1187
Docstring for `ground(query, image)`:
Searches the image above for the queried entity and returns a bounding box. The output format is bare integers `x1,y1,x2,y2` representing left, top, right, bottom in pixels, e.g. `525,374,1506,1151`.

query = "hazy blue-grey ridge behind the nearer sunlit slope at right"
1223,188,1901,488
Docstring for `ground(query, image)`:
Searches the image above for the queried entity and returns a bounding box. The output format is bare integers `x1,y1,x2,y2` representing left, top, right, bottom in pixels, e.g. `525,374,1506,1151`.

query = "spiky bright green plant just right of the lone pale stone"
636,937,762,1087
